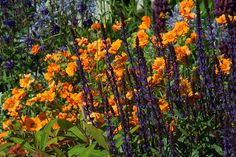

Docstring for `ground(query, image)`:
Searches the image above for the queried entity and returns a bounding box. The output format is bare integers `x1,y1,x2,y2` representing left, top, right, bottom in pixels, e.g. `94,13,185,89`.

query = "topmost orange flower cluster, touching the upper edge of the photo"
179,0,196,19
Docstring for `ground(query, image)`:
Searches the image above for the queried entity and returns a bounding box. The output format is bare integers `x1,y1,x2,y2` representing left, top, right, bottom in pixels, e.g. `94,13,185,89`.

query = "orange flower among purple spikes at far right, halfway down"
215,55,232,74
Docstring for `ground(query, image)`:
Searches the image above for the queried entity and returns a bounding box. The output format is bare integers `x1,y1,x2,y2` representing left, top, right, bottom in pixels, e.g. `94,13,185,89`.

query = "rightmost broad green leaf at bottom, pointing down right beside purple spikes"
85,123,108,150
